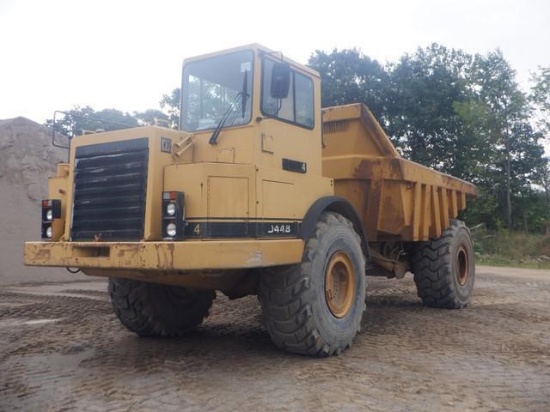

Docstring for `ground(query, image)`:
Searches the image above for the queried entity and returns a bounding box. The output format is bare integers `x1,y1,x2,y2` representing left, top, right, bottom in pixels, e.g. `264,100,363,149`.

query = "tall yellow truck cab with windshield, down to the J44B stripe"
175,45,332,238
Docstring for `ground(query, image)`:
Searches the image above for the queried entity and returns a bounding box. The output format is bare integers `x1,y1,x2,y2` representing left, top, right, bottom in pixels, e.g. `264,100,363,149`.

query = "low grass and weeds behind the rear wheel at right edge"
472,226,550,269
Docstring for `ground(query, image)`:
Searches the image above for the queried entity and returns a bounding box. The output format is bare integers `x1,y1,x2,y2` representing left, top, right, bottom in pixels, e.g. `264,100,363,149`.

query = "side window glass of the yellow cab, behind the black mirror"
261,58,314,129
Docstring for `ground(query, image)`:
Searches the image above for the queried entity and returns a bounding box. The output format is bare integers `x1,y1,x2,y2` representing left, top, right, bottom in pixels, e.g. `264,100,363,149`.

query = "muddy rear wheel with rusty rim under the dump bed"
412,220,475,309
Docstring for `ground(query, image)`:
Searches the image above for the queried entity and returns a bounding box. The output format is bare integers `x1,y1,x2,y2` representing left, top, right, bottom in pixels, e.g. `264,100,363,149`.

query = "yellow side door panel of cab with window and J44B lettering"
257,55,330,236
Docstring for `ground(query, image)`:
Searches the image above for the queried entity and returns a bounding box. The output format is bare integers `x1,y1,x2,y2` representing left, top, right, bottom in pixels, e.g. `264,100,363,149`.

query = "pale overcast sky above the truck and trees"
0,0,550,122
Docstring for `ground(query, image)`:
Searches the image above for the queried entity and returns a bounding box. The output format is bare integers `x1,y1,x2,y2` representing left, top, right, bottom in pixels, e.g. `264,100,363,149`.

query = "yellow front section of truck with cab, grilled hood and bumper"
26,44,333,270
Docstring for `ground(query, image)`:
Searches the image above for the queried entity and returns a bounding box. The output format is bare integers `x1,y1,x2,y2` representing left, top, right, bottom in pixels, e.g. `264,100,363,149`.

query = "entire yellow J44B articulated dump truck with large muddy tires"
25,44,476,356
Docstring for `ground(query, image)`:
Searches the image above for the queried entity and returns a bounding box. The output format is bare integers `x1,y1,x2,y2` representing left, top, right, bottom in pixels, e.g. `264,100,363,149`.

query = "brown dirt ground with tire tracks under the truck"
0,267,550,412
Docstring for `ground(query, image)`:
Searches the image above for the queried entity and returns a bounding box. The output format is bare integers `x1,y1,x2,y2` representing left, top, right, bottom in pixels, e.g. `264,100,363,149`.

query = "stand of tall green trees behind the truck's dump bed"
309,44,550,230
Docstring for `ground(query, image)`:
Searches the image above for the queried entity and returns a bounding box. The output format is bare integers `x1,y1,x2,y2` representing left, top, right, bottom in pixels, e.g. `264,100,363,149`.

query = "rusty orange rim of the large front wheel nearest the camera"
325,252,355,318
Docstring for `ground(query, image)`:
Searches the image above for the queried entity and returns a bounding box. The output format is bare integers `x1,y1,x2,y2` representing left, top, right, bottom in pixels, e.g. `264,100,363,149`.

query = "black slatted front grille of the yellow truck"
71,138,149,241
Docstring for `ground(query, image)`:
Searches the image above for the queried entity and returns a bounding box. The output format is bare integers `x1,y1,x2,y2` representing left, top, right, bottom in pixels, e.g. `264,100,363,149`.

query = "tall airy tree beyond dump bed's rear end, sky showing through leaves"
471,50,544,228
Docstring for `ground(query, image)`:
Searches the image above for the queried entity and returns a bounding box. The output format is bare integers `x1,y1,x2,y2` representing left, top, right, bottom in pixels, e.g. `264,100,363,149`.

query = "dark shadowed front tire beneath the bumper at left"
109,278,216,337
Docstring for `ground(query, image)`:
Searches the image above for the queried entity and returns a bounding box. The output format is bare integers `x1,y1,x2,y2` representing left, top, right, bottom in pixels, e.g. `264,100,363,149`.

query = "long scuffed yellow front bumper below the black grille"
24,239,304,271
